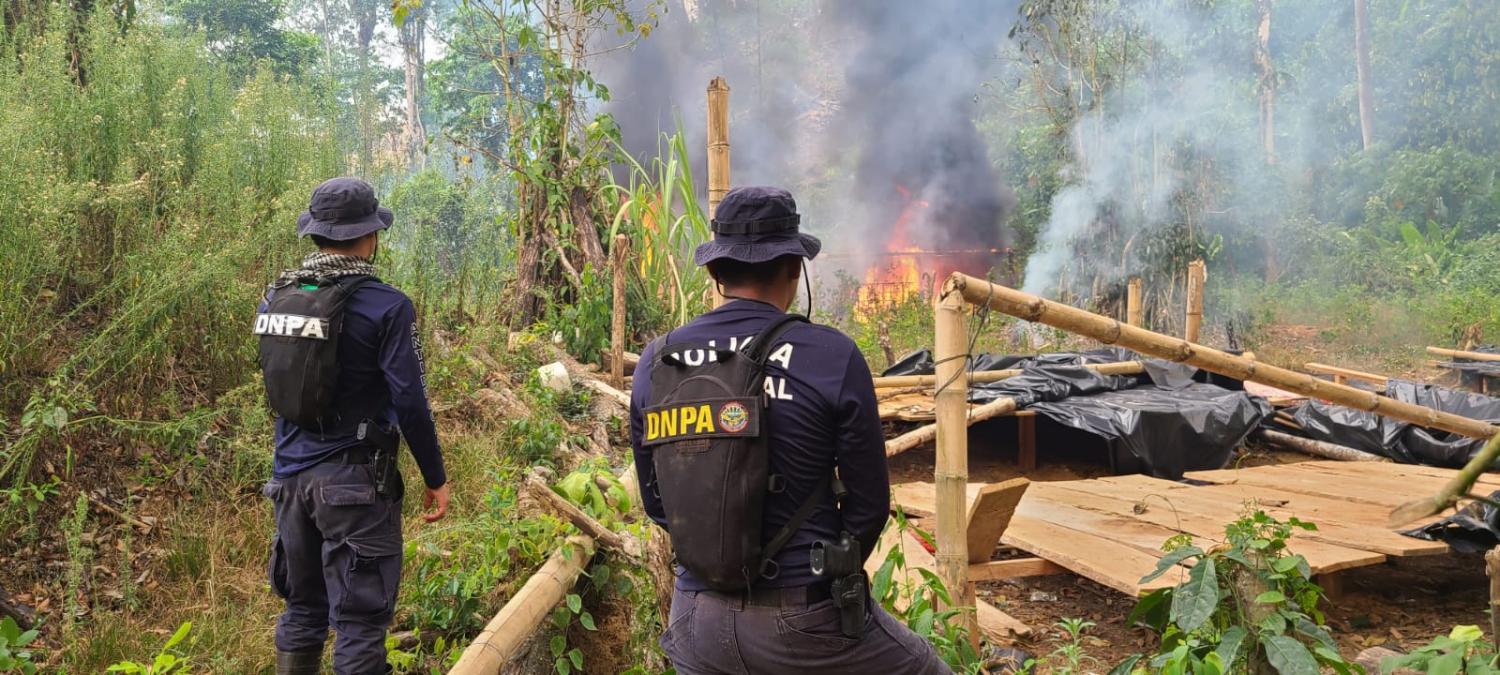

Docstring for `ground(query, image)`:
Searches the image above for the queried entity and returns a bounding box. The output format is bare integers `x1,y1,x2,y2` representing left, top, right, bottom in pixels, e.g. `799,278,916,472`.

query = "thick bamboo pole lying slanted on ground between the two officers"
449,536,594,675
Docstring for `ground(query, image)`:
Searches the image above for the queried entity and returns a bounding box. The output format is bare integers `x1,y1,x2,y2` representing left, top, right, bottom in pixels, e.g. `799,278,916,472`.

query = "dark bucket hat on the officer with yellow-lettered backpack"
693,188,824,266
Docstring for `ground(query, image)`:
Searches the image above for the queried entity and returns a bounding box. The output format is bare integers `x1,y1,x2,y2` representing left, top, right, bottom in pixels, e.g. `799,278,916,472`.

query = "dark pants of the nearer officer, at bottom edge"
662,591,953,675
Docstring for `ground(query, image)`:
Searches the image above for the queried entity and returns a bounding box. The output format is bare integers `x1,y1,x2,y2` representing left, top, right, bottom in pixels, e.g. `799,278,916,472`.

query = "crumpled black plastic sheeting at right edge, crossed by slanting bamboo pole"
1293,380,1500,468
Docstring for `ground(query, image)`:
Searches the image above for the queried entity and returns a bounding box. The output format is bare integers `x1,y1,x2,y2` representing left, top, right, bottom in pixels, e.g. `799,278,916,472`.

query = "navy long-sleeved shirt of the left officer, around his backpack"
261,284,449,488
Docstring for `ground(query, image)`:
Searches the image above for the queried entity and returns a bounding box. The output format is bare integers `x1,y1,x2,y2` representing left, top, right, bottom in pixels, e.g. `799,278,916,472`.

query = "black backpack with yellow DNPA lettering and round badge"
642,314,824,591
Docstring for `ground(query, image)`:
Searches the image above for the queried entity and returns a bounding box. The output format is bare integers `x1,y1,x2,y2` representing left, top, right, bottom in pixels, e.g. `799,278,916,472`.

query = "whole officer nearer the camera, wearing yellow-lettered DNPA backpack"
630,188,951,675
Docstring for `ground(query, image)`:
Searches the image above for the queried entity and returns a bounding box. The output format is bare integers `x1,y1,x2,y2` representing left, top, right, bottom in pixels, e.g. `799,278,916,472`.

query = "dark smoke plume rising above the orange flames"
593,0,1016,272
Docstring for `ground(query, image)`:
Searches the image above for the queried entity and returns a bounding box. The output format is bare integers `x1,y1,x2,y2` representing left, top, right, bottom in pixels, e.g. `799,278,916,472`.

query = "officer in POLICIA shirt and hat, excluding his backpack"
630,188,951,675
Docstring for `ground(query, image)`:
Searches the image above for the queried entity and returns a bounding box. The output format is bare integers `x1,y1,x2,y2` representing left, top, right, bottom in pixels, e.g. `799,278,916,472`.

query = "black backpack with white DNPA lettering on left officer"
255,275,380,432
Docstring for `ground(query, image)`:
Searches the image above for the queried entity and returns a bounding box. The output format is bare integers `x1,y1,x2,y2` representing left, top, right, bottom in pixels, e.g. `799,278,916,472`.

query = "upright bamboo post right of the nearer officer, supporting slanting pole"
933,287,980,642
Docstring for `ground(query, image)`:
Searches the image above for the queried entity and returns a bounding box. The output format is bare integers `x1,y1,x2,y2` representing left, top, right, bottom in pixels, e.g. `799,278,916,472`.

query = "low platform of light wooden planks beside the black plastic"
894,462,1464,596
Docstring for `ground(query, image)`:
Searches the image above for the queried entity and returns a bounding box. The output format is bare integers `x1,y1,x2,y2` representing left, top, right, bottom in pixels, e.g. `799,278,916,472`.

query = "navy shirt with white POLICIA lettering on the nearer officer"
630,300,891,591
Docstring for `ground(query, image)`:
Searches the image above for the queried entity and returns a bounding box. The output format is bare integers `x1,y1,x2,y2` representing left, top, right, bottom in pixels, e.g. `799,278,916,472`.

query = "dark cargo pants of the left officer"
266,458,402,675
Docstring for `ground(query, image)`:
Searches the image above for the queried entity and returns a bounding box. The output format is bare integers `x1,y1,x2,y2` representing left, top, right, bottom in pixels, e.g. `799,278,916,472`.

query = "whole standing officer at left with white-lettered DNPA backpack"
257,179,449,675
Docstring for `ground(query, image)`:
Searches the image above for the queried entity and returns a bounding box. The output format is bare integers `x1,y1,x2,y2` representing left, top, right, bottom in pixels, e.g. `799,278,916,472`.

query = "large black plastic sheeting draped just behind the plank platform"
884,348,1272,480
